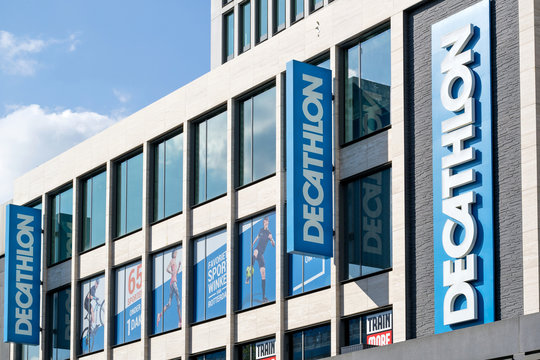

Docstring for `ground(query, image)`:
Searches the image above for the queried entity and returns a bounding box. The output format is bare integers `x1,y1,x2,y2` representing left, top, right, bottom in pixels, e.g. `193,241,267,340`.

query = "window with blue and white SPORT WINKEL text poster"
193,230,227,322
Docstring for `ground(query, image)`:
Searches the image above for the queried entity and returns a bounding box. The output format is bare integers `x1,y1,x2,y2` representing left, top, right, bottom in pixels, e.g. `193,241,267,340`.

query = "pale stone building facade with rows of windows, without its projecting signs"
0,0,540,360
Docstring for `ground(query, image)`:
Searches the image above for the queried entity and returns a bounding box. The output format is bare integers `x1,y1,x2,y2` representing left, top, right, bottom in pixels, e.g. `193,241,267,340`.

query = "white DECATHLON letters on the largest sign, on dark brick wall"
437,24,478,325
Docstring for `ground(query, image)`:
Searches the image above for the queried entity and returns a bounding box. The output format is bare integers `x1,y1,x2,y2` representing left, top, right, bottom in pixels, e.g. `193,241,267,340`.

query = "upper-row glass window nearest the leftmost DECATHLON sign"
49,188,73,265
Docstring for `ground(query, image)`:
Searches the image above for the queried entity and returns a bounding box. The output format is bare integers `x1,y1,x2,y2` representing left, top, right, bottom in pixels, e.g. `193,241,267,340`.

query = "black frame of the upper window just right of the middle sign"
336,22,392,148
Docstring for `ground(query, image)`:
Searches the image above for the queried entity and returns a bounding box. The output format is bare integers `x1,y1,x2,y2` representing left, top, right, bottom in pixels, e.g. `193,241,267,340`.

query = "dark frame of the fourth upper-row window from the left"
148,125,186,226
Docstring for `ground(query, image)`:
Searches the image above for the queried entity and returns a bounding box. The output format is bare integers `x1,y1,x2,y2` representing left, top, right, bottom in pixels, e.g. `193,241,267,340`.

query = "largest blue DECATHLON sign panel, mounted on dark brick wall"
431,0,495,333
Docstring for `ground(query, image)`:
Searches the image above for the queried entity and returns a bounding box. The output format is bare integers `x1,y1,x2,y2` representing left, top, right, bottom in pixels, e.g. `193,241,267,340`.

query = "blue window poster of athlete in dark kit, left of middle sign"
238,212,276,310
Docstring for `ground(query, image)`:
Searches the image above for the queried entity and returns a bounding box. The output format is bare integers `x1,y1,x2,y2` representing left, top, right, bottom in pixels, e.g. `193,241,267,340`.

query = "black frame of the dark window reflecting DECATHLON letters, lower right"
339,162,394,284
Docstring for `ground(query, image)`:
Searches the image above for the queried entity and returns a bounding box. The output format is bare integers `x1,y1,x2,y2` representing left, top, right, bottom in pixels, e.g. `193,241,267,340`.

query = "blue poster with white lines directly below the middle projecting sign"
289,254,332,295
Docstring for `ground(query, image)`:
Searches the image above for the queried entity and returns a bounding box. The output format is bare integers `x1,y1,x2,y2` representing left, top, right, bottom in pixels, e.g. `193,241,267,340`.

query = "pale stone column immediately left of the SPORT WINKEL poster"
184,121,193,360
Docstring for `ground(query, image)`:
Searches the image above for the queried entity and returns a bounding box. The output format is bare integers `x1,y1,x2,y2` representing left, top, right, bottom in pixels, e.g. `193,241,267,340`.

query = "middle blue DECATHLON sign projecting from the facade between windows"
286,60,333,257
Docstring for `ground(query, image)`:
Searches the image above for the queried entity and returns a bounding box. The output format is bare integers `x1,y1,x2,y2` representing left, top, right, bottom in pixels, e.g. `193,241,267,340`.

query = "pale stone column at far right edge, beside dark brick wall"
519,0,540,314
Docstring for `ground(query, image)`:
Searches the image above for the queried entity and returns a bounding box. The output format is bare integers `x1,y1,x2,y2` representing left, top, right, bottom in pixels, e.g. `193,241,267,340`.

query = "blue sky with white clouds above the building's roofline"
0,0,210,203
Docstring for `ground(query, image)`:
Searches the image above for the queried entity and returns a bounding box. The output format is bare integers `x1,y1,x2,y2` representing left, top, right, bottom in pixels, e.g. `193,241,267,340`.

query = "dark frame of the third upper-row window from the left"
111,147,146,241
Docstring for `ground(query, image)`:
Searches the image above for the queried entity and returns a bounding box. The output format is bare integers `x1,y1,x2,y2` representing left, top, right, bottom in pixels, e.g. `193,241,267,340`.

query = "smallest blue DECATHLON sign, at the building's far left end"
4,205,41,345
